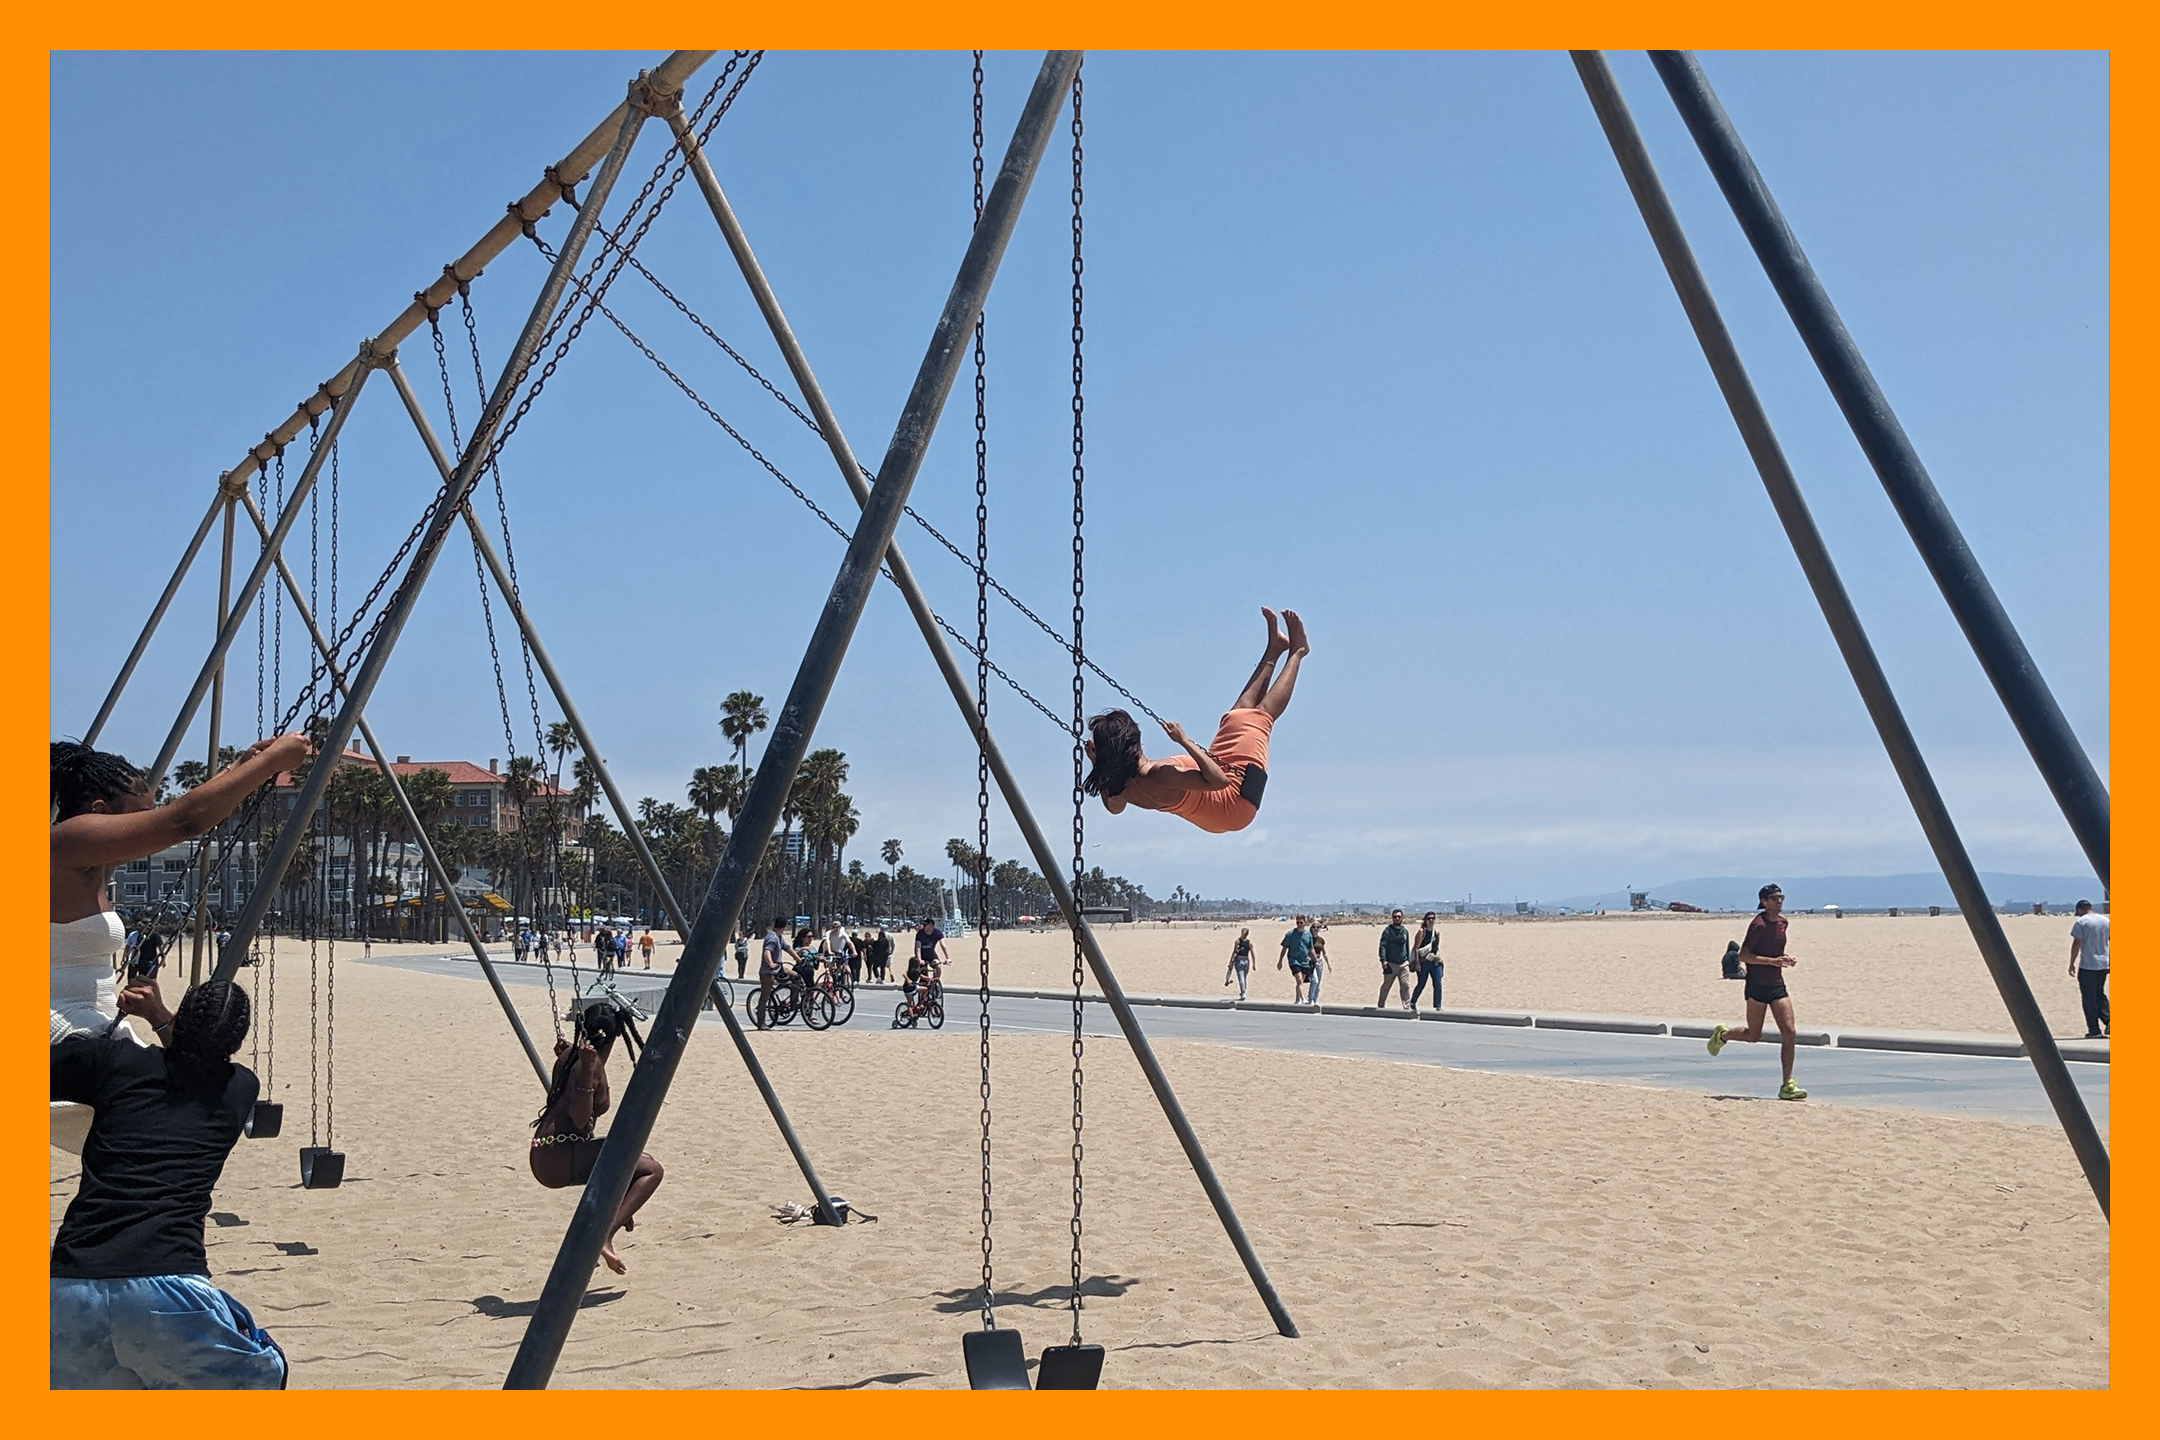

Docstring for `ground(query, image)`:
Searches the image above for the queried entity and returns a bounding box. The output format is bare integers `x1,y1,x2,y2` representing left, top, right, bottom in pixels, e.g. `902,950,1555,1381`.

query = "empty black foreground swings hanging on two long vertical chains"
961,50,1104,1390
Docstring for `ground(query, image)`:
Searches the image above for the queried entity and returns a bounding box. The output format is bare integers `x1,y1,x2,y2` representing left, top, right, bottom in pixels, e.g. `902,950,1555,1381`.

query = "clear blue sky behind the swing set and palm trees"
52,52,2108,900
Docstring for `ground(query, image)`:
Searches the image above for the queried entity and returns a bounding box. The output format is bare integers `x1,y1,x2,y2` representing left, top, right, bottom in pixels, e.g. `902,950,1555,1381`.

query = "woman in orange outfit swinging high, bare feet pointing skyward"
1086,609,1309,836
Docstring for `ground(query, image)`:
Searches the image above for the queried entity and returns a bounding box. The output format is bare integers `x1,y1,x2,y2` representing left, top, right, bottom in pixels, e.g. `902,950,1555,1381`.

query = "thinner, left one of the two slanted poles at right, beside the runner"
1572,50,2108,1215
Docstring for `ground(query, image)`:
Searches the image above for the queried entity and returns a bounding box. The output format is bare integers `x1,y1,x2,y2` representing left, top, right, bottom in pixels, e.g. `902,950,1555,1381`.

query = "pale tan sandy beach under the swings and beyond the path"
52,949,2110,1388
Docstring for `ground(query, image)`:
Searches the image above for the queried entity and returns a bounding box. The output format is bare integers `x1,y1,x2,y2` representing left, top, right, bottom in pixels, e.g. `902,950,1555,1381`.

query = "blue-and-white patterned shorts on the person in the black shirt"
52,1276,285,1390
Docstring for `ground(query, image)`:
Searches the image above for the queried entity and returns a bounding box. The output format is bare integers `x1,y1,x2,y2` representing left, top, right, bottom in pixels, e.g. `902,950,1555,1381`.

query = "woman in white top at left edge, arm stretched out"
52,734,309,1153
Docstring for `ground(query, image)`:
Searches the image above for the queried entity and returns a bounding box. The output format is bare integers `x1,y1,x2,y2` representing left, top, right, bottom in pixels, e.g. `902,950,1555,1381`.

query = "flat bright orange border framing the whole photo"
0,0,2160,1436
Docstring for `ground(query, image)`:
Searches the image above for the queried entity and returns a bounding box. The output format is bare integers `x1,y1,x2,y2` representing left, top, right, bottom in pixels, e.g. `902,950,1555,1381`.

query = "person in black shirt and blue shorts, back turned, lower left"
52,980,285,1390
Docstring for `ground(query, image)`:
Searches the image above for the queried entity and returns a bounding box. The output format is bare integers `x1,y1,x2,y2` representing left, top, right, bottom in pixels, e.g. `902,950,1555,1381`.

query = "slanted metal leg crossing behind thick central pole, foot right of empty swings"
667,104,1298,1336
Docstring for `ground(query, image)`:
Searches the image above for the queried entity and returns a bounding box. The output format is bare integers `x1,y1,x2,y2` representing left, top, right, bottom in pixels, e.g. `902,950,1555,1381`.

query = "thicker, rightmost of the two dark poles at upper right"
1650,50,2110,885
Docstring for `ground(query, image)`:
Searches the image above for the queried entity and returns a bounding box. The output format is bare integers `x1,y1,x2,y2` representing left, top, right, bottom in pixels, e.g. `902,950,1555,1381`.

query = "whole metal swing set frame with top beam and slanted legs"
84,50,2110,1388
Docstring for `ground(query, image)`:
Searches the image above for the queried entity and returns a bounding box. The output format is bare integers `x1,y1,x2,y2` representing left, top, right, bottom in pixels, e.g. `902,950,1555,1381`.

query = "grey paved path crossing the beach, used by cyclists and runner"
358,954,2112,1133
